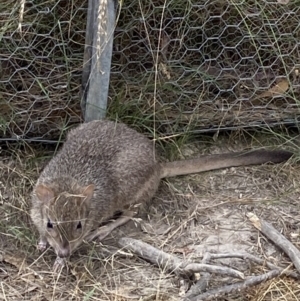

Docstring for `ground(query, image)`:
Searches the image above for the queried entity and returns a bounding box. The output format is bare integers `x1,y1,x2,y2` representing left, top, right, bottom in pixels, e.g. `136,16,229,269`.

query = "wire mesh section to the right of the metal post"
110,0,300,134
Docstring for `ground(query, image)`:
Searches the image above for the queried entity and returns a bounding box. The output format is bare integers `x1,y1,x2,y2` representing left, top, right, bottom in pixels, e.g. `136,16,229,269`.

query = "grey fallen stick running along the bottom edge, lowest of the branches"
184,270,280,301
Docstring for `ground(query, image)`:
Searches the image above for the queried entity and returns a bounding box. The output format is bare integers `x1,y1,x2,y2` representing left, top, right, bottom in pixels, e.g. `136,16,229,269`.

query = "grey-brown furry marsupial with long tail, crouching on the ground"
31,120,292,257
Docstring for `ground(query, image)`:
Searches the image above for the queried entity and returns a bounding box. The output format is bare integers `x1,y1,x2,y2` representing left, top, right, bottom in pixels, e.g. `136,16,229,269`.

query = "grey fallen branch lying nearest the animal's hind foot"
118,237,245,279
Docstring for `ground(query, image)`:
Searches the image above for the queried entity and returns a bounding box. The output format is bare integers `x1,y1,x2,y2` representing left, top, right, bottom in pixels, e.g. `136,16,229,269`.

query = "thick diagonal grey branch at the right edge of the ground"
247,213,300,273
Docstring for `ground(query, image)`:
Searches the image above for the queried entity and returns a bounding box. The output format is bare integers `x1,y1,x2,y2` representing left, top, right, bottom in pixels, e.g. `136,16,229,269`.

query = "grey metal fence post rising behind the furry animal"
82,0,116,122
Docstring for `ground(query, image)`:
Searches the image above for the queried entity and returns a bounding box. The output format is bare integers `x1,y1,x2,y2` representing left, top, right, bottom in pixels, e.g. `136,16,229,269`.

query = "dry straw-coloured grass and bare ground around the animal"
0,129,300,301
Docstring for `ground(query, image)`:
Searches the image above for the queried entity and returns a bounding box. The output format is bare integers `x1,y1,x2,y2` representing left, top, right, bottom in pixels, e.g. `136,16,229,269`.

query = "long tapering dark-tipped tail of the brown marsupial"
161,150,293,178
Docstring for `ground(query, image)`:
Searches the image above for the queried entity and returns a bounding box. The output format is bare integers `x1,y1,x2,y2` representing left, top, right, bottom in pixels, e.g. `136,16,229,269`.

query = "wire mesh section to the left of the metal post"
0,0,87,139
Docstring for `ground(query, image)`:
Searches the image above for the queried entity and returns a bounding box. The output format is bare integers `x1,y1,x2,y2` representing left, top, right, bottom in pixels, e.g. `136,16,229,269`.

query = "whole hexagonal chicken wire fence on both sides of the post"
0,0,300,139
